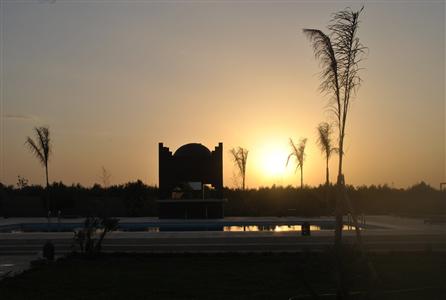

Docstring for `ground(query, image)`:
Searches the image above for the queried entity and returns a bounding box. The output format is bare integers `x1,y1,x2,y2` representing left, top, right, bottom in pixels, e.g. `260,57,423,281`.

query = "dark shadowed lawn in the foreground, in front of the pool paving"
0,252,446,299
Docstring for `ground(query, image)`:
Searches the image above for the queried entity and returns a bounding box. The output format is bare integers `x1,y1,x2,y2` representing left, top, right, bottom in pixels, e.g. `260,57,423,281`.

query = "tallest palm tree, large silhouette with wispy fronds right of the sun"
303,8,365,246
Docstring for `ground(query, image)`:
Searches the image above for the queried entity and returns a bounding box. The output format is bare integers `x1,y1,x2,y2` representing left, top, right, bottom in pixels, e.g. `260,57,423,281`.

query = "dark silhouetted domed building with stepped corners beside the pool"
158,143,225,219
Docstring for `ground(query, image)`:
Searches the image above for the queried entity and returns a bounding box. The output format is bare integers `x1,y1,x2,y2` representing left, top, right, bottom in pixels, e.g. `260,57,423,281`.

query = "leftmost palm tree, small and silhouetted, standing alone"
25,126,51,211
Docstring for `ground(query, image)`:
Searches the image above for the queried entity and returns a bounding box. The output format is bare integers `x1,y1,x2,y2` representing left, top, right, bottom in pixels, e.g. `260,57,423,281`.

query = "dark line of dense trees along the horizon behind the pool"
0,177,446,217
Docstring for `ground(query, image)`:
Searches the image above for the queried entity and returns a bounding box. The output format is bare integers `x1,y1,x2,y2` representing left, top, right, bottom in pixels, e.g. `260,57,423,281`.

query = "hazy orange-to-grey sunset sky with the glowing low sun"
0,0,446,188
